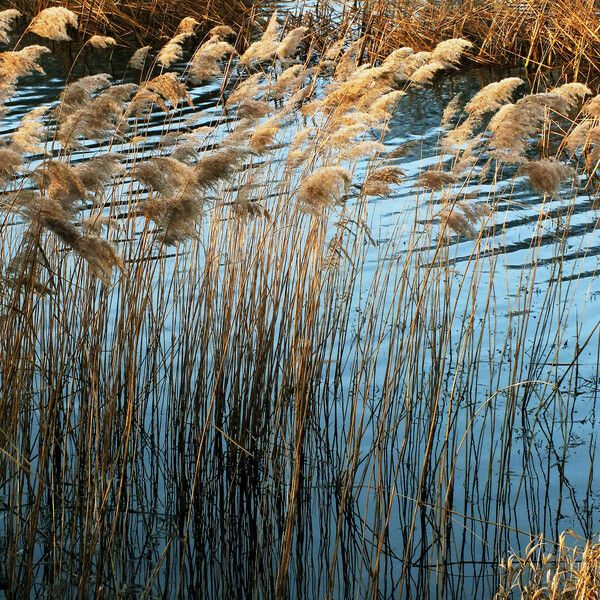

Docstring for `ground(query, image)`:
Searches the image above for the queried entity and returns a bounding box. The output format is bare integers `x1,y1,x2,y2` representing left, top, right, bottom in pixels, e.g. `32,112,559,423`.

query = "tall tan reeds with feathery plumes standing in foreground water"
0,9,600,598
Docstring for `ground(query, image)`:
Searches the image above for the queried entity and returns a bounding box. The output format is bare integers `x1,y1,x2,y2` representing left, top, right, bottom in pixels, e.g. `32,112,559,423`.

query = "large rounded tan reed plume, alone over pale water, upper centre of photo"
298,167,352,216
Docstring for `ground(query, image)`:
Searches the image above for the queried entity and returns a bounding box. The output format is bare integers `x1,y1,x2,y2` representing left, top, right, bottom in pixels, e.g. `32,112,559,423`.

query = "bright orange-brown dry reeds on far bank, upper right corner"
361,0,600,85
